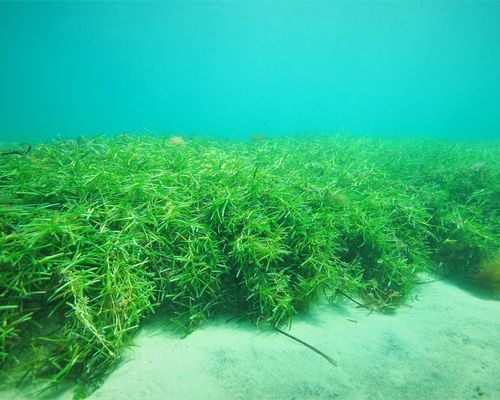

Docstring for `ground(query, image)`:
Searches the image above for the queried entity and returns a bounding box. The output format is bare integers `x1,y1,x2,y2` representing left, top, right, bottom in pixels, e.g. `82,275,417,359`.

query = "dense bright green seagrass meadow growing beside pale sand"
0,135,500,397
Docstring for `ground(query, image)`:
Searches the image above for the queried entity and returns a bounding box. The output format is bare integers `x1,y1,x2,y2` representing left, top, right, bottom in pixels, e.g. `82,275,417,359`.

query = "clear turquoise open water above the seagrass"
0,1,500,141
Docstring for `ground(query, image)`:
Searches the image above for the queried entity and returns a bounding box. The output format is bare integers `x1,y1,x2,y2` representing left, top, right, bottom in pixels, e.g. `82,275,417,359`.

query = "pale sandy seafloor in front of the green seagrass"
0,281,500,400
